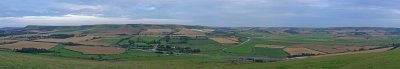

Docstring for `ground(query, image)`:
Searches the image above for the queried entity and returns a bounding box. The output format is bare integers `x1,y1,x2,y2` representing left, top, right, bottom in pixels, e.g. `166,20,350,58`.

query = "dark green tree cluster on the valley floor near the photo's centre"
156,46,201,54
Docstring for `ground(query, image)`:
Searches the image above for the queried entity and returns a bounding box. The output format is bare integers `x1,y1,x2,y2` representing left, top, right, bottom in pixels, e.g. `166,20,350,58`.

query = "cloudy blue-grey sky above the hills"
0,0,400,27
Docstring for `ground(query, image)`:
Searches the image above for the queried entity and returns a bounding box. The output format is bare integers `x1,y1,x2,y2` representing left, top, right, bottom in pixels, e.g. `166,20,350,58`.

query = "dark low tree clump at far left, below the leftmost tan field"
16,48,53,54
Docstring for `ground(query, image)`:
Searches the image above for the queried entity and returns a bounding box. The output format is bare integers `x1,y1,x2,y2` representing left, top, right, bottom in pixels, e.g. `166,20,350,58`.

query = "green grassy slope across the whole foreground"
0,50,400,69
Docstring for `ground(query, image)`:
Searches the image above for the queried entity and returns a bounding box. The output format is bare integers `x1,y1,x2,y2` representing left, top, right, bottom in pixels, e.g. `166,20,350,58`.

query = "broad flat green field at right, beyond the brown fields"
258,34,400,46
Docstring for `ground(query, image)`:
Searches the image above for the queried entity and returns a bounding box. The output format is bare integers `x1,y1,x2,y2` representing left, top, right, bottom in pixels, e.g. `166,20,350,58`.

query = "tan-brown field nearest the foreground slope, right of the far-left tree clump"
65,46,125,54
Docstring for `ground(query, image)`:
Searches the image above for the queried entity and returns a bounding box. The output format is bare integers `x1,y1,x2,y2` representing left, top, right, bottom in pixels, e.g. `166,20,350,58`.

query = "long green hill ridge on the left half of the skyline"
23,24,209,33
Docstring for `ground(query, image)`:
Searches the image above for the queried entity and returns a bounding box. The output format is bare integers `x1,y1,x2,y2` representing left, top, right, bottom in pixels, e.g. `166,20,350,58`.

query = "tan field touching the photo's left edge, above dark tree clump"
0,41,57,49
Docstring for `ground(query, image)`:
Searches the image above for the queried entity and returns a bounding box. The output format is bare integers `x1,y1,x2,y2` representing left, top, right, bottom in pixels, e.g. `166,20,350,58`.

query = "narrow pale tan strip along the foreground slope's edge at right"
311,47,394,58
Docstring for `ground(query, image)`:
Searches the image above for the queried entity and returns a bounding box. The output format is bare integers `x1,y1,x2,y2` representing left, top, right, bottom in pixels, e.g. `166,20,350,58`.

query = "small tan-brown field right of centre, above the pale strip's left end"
283,48,326,55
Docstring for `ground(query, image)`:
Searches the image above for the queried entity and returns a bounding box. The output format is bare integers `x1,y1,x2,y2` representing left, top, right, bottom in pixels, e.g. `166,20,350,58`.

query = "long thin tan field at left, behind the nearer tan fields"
35,36,96,42
